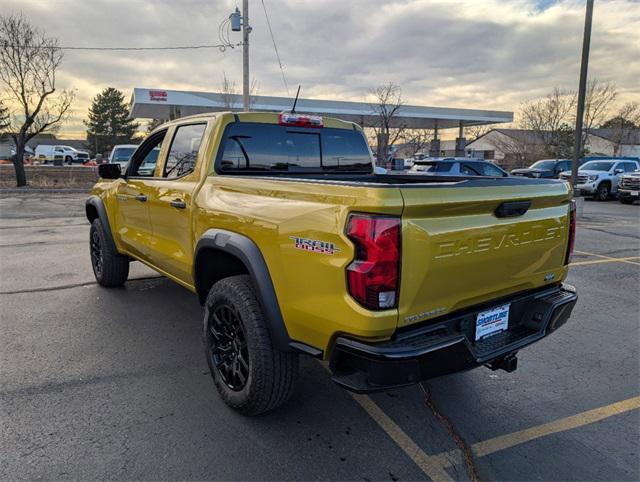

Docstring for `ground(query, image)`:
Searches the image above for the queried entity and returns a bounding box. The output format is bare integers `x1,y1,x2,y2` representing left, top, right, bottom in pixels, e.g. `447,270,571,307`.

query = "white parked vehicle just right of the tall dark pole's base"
560,158,640,201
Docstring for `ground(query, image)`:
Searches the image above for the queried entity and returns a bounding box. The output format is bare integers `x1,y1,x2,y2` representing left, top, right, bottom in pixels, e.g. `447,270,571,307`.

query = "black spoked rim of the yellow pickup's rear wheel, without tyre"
208,303,249,392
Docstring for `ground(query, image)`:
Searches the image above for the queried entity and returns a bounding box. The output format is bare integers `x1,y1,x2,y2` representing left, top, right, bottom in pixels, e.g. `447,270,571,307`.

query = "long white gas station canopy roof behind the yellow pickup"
129,88,513,129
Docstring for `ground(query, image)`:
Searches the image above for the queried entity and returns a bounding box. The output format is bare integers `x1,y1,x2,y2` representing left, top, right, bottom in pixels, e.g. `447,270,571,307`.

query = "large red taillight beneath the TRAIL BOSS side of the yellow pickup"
347,214,401,310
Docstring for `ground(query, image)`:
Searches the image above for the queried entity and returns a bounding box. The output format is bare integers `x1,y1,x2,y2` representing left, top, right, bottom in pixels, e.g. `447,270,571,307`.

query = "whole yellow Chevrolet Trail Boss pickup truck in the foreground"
86,113,577,415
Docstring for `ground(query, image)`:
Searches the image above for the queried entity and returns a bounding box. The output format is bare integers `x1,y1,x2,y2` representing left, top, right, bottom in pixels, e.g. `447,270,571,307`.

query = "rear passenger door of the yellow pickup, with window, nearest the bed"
147,122,207,285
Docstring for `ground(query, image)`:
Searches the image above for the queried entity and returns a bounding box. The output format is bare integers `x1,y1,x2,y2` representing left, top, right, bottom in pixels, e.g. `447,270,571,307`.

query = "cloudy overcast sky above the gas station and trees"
5,0,640,137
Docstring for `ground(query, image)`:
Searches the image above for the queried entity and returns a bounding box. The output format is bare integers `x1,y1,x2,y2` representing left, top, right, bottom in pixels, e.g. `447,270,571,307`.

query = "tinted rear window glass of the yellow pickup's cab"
216,122,372,174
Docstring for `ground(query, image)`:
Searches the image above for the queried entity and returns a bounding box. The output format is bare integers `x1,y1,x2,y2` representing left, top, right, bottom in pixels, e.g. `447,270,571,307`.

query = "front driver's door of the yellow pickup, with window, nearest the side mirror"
116,130,167,259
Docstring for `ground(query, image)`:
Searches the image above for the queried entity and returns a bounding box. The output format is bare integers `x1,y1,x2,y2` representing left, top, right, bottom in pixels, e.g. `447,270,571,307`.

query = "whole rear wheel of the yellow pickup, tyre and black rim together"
204,275,298,415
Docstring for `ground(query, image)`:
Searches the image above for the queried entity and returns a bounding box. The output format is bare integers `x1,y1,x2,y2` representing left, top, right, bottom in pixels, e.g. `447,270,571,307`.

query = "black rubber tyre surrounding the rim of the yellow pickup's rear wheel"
203,275,298,415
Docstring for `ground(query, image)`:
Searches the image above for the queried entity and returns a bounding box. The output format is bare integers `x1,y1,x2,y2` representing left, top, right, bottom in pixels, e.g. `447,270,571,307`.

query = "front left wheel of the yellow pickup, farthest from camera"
89,218,129,288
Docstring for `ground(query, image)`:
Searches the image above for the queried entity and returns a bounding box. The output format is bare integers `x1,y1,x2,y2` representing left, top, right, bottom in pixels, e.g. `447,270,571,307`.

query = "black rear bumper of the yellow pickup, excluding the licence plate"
330,285,578,393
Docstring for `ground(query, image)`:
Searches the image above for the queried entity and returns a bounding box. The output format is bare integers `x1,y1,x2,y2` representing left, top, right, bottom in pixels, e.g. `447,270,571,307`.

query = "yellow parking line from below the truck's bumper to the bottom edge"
321,363,453,482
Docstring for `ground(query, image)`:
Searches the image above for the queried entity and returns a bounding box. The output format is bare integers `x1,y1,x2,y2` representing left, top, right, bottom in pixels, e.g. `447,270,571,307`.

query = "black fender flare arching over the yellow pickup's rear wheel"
193,229,295,351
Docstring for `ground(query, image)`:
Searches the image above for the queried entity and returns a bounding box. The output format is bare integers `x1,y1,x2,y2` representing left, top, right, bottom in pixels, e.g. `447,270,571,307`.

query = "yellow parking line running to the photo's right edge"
431,396,640,468
